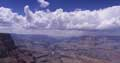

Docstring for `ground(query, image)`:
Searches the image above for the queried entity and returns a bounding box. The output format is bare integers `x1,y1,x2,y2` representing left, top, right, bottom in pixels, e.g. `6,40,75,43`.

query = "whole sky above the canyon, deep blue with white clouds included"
0,0,120,35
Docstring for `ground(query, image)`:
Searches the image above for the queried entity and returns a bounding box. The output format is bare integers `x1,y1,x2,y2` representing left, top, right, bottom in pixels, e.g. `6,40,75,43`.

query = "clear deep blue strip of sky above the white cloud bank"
0,0,120,14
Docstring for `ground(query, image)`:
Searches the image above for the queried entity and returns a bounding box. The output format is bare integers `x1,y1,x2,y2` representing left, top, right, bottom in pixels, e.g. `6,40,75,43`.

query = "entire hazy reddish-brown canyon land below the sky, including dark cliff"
0,34,120,63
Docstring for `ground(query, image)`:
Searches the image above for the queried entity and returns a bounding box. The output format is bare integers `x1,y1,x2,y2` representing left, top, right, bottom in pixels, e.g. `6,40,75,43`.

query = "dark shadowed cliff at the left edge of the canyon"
0,33,15,58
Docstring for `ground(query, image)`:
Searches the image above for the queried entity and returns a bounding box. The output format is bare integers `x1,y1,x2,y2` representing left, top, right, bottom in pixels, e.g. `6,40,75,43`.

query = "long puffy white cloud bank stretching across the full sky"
0,6,120,33
